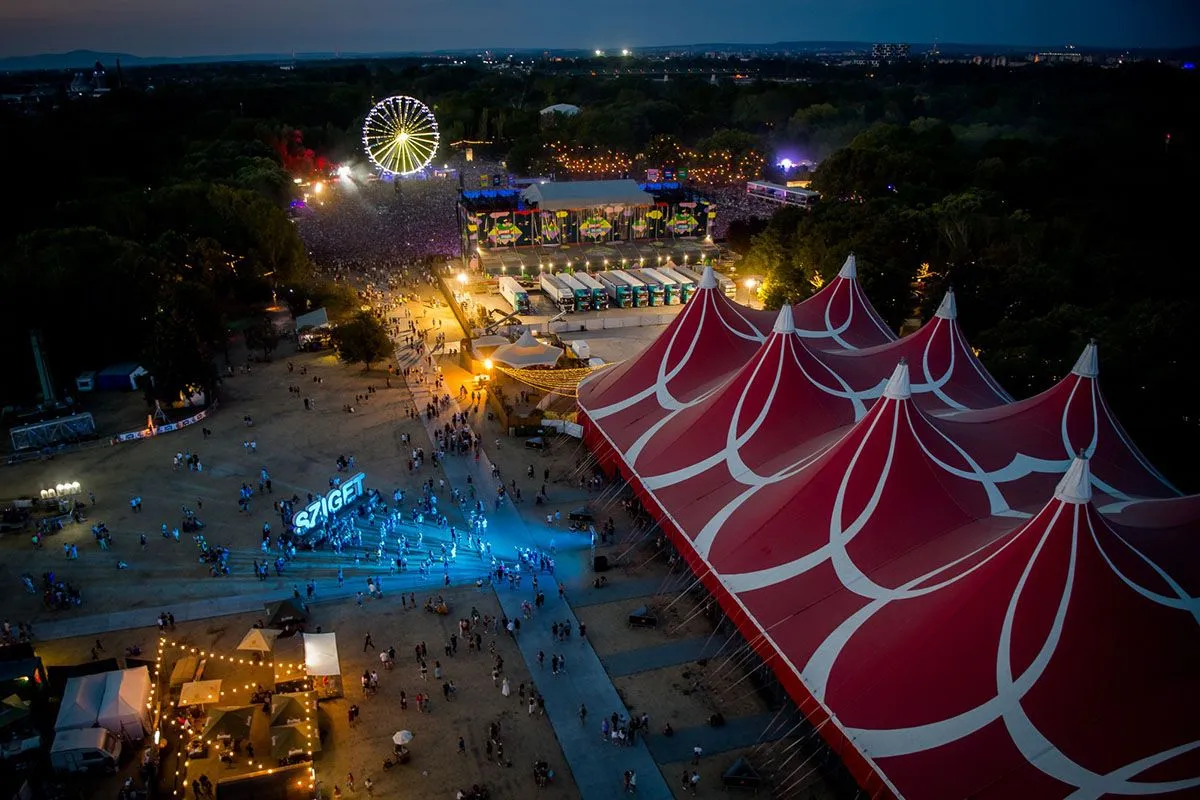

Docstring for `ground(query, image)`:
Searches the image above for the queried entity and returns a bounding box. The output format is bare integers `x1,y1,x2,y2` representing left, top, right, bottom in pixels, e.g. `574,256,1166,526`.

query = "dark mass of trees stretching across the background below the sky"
0,60,1200,488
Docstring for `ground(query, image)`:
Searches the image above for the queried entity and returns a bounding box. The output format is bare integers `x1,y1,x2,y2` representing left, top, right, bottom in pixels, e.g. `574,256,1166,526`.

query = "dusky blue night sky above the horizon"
0,0,1200,56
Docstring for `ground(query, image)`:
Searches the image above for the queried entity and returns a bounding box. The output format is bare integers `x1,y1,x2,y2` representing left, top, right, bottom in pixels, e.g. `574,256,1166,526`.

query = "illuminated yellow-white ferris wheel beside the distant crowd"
362,95,439,175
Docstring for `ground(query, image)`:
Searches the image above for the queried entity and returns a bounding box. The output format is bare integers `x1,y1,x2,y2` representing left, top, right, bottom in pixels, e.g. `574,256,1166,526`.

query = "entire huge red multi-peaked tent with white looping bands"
580,263,1200,799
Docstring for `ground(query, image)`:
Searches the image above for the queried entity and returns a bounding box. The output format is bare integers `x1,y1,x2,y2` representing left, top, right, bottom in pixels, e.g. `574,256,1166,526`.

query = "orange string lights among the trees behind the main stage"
546,142,767,185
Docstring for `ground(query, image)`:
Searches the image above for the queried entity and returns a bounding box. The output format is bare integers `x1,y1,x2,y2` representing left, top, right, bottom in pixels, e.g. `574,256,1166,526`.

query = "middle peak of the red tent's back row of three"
828,291,1013,410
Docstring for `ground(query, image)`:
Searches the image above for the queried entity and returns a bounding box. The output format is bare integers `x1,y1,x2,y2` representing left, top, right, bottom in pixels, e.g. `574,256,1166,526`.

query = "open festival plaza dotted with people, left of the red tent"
0,271,833,798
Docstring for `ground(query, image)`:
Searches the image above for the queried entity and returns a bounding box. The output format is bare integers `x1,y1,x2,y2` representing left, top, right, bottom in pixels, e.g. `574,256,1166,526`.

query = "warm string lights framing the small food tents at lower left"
146,637,317,796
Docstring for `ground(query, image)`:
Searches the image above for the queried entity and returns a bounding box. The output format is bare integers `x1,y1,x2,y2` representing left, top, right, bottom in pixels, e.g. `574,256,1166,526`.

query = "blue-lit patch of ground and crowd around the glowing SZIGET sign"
272,465,604,600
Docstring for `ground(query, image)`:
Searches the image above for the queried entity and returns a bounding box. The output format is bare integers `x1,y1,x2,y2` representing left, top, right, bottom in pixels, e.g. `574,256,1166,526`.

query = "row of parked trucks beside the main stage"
499,265,736,313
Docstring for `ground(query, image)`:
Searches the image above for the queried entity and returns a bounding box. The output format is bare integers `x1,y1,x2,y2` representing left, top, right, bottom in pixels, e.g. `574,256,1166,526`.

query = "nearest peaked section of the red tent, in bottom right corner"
835,458,1200,800
